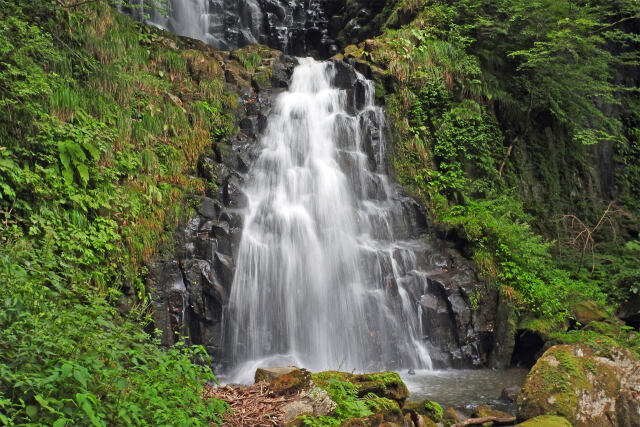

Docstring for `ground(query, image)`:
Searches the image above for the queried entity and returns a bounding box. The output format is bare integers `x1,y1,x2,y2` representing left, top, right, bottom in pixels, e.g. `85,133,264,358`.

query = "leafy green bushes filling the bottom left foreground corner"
0,232,227,426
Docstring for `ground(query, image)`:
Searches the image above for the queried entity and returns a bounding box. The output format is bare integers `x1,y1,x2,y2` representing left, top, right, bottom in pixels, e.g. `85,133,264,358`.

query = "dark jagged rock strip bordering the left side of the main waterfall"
146,56,295,360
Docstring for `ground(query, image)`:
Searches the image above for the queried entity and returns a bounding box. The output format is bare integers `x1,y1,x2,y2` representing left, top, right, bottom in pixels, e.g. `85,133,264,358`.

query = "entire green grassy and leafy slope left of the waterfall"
0,0,238,426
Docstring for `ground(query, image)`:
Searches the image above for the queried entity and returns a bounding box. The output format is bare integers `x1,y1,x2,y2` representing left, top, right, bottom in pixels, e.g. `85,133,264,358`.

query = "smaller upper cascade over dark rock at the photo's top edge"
118,0,337,57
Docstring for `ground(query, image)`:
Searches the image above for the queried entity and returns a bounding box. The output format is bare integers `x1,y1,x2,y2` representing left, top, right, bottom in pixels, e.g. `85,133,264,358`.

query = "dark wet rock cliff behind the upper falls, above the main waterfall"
119,0,394,59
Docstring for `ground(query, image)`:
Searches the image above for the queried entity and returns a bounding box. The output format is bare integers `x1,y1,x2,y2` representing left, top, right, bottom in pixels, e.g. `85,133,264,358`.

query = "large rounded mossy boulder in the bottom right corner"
518,345,640,427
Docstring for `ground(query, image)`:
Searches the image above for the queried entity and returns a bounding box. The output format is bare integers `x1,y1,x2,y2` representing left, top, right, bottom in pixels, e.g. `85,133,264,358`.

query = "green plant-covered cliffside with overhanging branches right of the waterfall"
368,0,640,321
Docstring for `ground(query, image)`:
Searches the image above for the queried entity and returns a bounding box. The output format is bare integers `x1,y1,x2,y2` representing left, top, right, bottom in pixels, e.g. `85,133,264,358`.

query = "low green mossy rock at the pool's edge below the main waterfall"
312,371,409,405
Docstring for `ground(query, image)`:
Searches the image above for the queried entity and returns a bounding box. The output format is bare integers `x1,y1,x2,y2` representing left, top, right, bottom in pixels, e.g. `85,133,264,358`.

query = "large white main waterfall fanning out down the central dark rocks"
224,58,431,379
